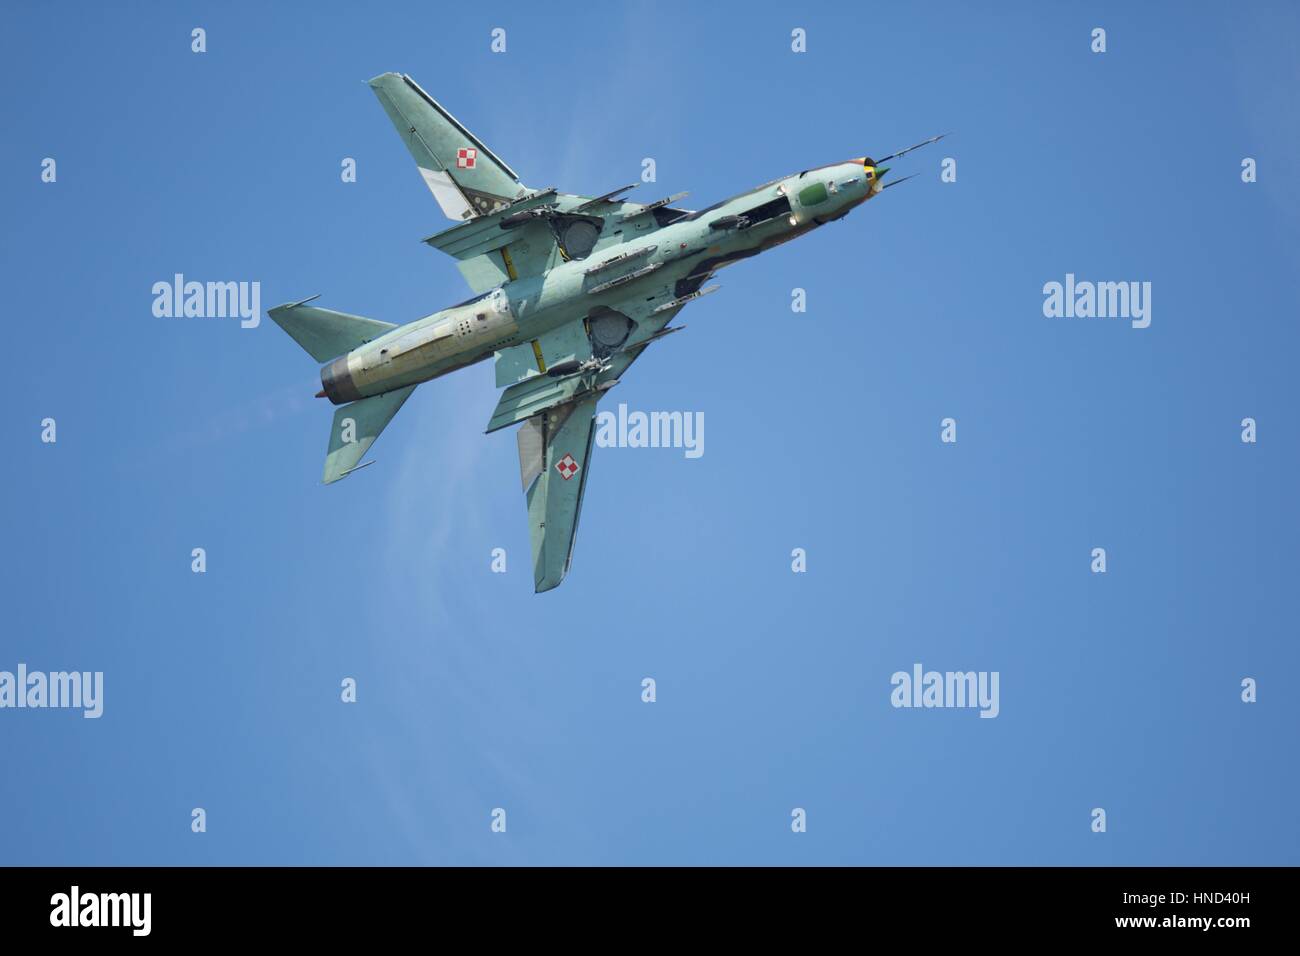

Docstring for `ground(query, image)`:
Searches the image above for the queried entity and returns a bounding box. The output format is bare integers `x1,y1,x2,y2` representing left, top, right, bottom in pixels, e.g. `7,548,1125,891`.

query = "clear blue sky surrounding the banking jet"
0,3,1300,865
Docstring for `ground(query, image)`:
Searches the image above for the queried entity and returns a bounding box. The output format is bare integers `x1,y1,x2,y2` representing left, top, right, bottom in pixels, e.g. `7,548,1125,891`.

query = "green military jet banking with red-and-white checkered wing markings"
268,73,943,592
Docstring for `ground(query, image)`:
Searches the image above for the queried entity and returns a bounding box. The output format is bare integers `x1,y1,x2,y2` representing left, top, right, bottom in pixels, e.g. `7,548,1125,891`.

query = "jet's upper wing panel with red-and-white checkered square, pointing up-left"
371,73,528,220
